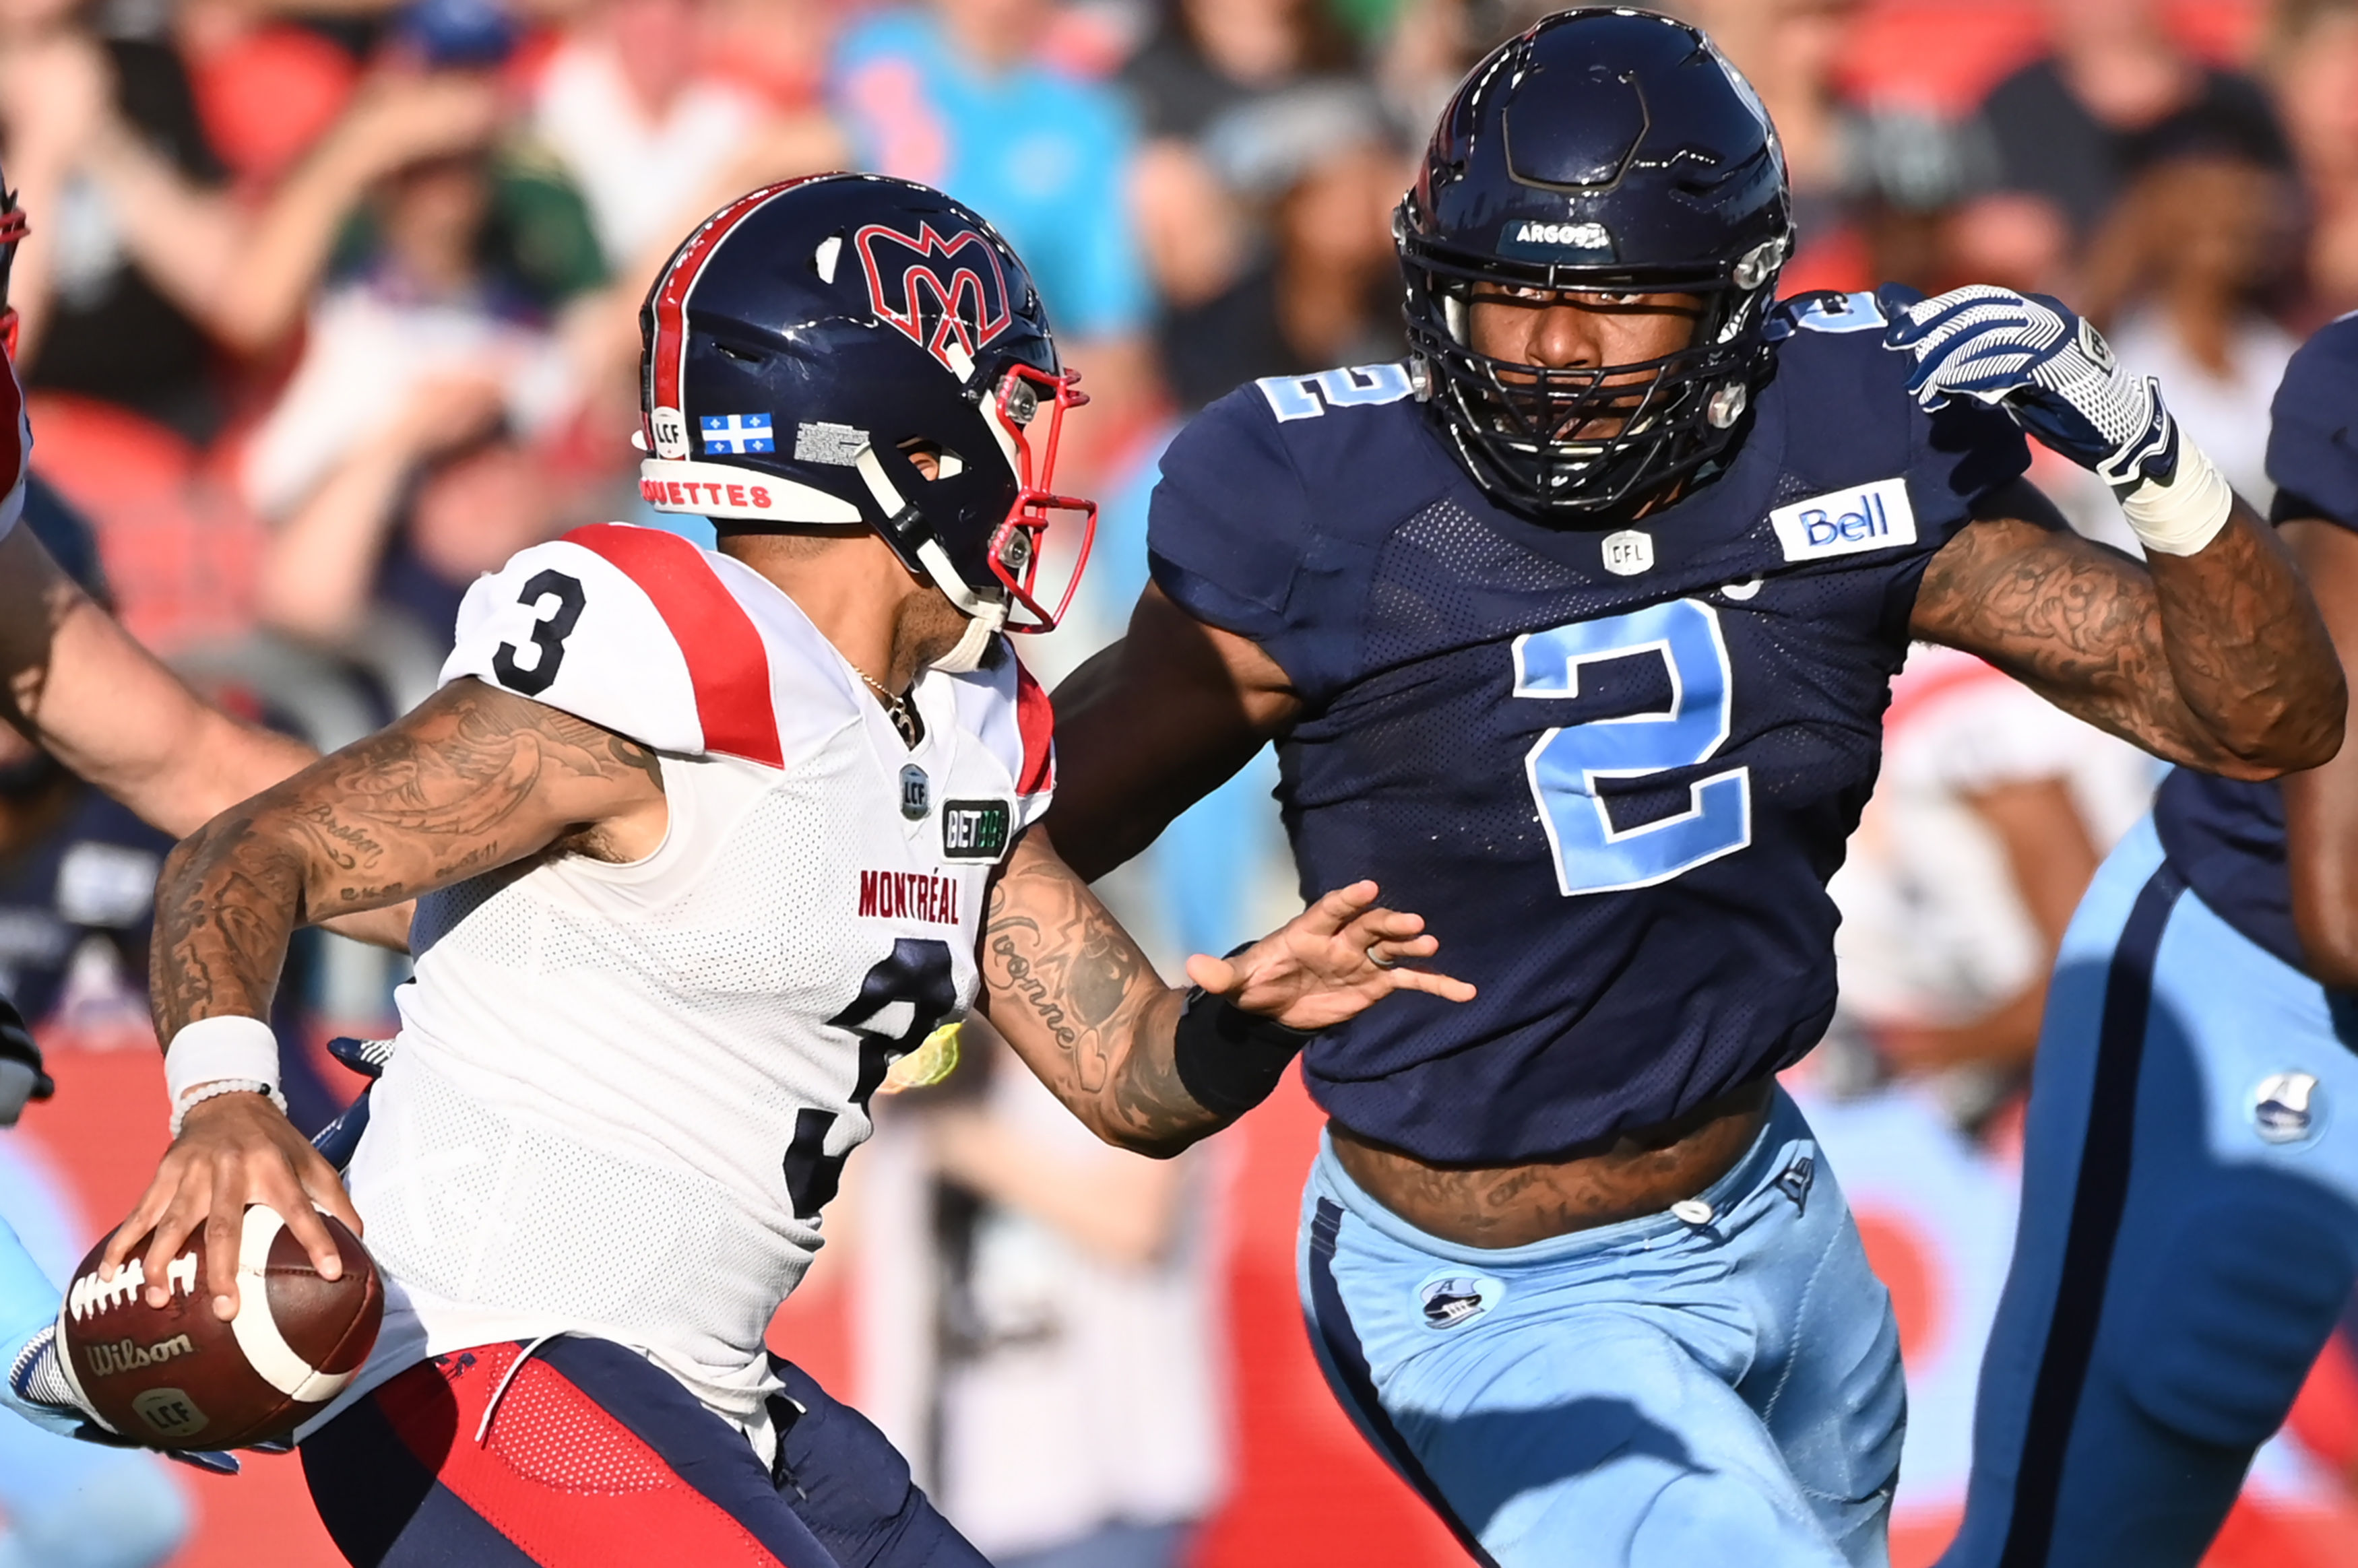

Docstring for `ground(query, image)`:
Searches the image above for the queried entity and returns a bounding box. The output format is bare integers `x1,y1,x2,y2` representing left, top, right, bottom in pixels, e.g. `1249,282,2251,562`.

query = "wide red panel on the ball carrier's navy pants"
371,1344,788,1568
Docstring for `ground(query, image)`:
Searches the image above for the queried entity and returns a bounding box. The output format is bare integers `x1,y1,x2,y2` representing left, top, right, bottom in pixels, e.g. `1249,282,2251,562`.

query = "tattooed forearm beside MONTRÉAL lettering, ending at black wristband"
984,835,1224,1153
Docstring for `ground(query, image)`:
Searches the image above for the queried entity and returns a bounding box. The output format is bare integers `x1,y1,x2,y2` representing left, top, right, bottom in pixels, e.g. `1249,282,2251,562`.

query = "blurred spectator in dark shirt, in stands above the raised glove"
1981,0,2292,240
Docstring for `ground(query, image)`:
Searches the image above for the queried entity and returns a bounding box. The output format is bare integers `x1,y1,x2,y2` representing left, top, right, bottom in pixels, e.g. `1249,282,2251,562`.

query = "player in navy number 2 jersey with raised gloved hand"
1047,9,2347,1568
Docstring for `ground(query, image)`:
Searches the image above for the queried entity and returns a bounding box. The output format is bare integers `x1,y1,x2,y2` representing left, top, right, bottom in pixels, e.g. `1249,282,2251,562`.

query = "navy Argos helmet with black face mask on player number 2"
1394,9,1792,519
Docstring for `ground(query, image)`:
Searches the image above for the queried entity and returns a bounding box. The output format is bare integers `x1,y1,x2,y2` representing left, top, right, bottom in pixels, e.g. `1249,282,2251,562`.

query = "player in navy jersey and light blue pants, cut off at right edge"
1941,316,2358,1568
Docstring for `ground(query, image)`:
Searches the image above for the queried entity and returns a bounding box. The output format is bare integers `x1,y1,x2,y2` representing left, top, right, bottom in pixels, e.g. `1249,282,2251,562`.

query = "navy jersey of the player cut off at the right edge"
2153,314,2358,967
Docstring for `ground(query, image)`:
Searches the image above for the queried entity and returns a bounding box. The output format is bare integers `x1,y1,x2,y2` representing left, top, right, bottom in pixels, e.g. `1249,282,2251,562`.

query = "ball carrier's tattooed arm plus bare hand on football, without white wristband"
102,679,668,1318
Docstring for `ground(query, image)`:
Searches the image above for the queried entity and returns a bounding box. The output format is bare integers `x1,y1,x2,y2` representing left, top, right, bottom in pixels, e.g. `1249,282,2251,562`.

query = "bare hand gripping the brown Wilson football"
99,1094,361,1323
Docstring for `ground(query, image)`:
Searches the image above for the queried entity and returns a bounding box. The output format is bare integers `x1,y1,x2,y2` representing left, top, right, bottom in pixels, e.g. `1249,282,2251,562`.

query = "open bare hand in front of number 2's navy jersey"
1186,882,1474,1031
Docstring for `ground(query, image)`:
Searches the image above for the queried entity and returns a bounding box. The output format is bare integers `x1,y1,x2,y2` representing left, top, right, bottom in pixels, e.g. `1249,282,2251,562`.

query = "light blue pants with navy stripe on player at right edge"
1941,820,2358,1568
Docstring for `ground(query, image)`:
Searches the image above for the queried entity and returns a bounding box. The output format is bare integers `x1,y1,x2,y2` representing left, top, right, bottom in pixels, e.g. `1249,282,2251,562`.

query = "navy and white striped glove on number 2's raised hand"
1877,283,2235,556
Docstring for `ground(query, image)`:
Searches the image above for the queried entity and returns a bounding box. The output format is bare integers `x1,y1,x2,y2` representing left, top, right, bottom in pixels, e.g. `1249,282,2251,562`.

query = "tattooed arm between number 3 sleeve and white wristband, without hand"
149,682,663,1040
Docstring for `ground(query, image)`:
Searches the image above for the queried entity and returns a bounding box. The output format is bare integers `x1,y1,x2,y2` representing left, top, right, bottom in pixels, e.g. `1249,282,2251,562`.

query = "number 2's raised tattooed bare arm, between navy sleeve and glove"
1913,481,2349,778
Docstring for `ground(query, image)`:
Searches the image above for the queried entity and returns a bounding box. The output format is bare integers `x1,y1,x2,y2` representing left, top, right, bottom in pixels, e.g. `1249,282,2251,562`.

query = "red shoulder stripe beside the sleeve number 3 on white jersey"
566,523,786,769
